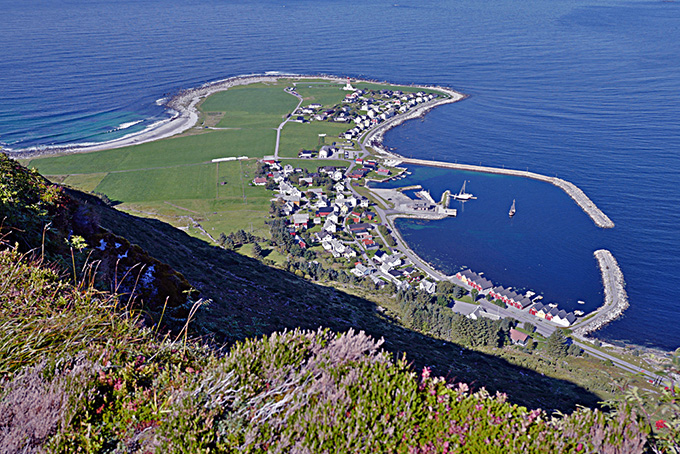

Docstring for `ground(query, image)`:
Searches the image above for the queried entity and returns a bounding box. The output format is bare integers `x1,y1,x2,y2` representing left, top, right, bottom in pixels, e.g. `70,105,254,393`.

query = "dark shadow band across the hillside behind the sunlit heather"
73,193,599,412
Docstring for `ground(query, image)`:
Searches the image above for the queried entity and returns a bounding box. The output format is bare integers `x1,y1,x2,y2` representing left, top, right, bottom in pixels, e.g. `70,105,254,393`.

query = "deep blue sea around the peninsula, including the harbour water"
0,0,680,350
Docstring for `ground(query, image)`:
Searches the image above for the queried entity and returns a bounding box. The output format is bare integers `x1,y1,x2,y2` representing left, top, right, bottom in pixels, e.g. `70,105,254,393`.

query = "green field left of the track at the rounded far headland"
200,81,298,129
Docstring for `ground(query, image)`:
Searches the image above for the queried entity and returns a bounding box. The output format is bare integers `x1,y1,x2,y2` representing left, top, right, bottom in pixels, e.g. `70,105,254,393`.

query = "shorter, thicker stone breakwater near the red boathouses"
574,249,629,337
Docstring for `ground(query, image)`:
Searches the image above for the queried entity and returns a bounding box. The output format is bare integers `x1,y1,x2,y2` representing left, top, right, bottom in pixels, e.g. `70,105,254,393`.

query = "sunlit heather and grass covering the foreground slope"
0,249,646,453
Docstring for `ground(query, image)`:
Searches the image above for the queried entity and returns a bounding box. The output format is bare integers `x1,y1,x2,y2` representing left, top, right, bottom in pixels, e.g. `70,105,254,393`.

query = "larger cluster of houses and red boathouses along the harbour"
252,146,577,344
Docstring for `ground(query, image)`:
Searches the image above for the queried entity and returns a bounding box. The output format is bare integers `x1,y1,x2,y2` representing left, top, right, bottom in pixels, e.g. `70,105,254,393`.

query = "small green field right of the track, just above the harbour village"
279,121,349,158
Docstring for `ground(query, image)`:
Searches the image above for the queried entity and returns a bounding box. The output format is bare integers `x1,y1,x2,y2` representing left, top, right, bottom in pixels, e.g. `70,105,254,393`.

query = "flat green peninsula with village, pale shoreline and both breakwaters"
16,74,627,342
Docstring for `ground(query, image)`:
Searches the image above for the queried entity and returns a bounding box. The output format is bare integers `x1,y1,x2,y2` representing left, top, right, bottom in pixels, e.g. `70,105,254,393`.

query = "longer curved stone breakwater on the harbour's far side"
399,157,614,229
